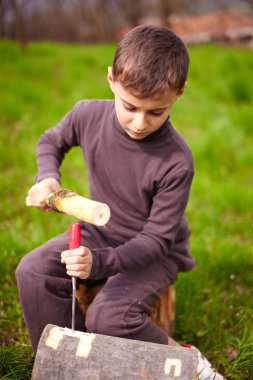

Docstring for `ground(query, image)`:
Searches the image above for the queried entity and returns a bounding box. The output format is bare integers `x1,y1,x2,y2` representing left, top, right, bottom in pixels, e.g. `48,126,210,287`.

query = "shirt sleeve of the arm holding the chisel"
90,169,193,279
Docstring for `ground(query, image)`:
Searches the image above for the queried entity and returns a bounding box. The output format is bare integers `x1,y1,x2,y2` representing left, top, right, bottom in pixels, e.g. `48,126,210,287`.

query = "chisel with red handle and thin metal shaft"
69,223,81,331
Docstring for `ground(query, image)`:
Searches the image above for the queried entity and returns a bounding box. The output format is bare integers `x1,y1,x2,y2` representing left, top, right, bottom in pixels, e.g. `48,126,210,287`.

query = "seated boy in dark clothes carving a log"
17,26,222,379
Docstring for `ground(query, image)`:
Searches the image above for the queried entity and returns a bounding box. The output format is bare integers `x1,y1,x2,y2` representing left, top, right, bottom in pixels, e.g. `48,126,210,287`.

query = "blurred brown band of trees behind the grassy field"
0,0,253,43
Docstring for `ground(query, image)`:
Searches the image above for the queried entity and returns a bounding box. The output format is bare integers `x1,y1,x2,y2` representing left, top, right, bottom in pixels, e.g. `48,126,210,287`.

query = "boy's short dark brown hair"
112,25,189,98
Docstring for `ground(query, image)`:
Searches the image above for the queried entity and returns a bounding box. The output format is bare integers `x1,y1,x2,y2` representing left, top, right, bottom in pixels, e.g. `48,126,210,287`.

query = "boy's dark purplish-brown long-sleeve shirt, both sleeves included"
37,100,194,279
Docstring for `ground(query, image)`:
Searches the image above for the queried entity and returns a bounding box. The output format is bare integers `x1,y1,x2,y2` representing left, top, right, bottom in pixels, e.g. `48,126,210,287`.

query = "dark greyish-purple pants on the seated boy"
16,229,178,352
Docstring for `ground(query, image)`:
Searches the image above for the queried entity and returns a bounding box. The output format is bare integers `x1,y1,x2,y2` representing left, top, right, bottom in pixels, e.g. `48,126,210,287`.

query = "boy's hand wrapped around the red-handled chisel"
61,247,93,280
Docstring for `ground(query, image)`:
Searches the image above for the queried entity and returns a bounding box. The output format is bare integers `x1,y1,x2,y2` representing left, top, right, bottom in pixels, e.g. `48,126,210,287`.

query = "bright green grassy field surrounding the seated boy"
0,42,253,380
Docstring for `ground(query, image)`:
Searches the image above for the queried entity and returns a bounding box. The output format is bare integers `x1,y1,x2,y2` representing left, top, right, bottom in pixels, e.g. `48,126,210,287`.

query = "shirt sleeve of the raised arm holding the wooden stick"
35,102,84,182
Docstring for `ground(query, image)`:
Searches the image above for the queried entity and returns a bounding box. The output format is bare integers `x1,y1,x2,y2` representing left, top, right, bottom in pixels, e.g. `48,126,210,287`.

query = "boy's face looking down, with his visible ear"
108,67,183,140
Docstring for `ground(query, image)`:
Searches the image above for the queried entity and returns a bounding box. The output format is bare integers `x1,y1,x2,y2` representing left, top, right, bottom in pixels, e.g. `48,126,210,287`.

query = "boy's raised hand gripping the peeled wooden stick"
26,178,61,211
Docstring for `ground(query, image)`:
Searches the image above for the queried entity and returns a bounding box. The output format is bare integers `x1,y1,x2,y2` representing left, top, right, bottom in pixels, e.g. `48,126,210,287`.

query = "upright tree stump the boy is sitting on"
77,281,175,337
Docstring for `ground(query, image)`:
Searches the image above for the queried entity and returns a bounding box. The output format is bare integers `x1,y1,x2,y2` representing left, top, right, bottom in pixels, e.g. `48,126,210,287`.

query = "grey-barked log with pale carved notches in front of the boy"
32,325,198,380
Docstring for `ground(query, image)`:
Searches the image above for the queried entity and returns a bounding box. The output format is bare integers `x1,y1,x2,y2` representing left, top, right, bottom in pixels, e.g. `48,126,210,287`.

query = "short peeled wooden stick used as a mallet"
46,189,110,226
